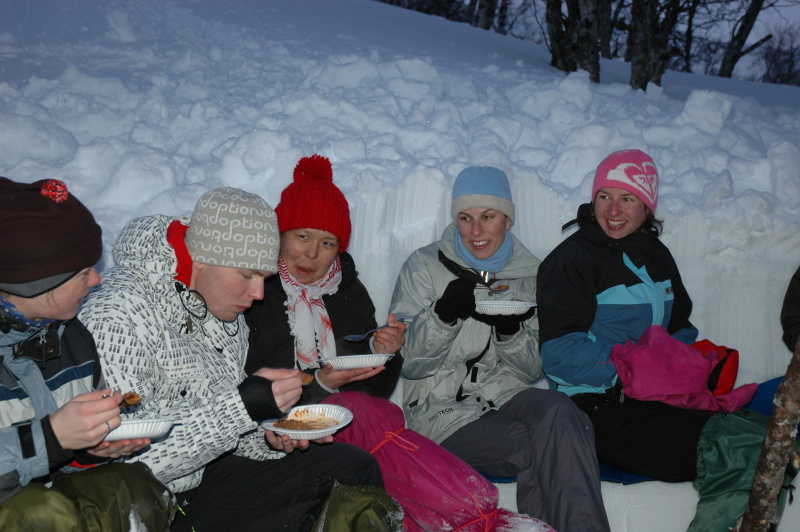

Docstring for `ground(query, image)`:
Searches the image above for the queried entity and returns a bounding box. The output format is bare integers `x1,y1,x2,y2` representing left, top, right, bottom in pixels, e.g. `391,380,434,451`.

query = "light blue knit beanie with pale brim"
450,166,515,224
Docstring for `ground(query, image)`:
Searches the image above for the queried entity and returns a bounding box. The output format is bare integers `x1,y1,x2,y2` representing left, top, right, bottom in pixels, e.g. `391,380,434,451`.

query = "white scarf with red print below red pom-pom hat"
278,257,342,369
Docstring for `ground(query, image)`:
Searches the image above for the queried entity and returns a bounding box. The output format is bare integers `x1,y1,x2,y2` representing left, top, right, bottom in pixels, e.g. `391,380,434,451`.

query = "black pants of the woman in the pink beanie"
572,388,715,482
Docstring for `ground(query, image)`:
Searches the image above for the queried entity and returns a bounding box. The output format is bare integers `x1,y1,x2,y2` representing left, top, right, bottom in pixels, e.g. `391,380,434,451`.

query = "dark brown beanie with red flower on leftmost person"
0,177,103,297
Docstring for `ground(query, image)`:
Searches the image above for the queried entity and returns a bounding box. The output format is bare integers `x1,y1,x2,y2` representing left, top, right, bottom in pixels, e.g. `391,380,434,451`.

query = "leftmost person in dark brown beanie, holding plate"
0,177,175,531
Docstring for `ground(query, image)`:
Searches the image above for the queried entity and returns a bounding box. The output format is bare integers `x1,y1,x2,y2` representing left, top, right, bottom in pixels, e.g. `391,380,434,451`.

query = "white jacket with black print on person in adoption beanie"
80,215,285,493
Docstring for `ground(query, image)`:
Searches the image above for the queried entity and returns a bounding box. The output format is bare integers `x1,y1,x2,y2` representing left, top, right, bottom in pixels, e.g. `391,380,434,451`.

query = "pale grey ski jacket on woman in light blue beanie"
390,224,542,443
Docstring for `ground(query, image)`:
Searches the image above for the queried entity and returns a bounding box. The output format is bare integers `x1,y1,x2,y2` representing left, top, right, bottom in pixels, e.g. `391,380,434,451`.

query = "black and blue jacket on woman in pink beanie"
536,204,697,395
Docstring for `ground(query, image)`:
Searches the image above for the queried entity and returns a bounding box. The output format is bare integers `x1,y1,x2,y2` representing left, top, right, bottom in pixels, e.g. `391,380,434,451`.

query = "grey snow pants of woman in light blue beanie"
441,388,610,532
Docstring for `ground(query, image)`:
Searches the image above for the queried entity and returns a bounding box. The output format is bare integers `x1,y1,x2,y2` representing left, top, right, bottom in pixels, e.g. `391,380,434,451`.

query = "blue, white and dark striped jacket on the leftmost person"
0,313,101,503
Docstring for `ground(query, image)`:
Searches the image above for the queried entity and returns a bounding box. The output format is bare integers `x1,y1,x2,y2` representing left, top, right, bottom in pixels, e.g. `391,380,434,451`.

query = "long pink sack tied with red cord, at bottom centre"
324,392,553,532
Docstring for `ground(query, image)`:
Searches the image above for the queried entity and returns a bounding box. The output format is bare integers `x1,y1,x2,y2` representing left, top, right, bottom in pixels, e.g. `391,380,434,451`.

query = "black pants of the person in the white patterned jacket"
171,443,383,532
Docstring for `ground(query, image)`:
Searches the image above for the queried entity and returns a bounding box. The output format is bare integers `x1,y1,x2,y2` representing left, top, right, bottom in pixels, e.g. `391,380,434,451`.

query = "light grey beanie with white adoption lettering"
186,188,280,273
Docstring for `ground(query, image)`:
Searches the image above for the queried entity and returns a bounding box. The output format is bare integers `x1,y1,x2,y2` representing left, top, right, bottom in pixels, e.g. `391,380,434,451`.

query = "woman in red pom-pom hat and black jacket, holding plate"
245,155,406,404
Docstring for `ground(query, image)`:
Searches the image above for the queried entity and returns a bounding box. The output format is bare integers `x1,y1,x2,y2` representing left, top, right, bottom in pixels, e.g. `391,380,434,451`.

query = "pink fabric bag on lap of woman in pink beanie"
611,325,758,412
